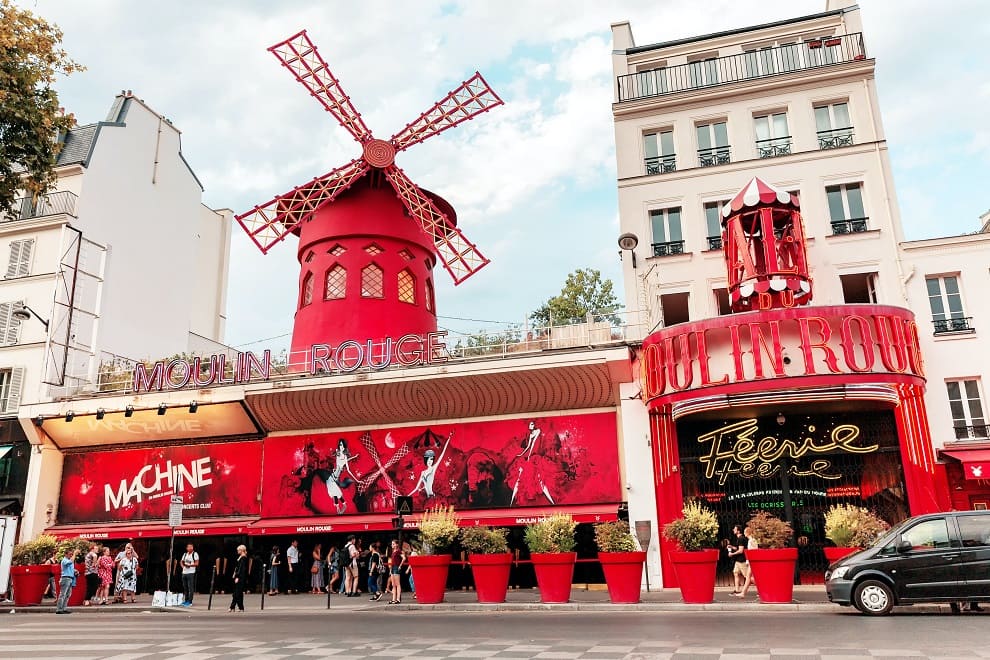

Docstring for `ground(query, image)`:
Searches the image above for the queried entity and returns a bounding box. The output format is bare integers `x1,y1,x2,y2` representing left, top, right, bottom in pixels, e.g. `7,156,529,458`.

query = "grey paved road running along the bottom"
0,609,990,660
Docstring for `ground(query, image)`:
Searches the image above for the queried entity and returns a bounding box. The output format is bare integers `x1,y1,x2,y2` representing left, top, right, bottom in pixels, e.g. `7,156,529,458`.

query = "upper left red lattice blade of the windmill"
268,30,371,142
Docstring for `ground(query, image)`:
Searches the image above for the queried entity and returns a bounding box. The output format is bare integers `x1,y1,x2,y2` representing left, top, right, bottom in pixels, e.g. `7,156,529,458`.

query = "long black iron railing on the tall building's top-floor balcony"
616,32,866,103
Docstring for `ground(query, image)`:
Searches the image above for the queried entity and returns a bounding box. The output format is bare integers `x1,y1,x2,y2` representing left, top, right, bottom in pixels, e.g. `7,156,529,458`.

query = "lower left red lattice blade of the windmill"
236,158,368,253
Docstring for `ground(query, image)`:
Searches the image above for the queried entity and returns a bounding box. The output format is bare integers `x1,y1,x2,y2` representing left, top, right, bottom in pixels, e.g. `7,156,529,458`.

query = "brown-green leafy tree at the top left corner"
0,0,82,213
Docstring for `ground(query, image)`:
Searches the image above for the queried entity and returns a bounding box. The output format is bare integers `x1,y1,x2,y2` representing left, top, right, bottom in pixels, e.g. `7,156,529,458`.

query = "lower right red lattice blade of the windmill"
385,166,489,284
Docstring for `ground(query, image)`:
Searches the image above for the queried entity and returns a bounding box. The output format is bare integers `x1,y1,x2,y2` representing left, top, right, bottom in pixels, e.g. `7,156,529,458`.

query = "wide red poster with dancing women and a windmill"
262,412,622,517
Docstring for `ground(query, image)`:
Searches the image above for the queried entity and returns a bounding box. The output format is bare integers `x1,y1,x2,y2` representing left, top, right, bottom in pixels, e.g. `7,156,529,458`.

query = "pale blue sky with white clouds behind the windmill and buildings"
19,0,990,351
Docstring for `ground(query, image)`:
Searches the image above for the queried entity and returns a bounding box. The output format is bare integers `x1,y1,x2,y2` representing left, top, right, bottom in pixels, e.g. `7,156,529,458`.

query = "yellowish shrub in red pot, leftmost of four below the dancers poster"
409,506,459,605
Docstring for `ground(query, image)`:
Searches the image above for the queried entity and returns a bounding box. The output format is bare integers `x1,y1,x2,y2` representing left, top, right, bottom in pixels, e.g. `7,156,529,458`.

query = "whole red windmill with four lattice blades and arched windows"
237,30,502,368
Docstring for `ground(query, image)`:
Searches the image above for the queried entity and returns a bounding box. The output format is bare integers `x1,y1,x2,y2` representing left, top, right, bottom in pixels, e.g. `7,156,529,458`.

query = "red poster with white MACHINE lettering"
58,441,261,524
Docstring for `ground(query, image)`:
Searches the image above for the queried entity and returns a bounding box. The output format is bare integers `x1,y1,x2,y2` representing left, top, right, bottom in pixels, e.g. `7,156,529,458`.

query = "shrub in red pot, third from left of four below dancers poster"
524,513,577,603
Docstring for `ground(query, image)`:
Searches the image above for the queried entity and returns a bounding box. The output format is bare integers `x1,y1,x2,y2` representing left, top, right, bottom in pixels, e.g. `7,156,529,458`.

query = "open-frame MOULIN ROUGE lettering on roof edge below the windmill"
133,330,450,392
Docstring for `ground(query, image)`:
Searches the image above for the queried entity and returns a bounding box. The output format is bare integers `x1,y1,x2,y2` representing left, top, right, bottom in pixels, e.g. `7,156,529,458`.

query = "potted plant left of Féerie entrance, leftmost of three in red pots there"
663,502,718,603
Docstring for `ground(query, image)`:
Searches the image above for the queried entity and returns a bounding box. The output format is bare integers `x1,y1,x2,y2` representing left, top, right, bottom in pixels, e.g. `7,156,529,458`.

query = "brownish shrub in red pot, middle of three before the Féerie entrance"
746,511,797,603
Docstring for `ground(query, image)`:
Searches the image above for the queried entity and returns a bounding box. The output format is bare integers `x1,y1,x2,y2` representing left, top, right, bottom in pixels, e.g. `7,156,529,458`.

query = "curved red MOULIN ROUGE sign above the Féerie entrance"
640,305,924,401
